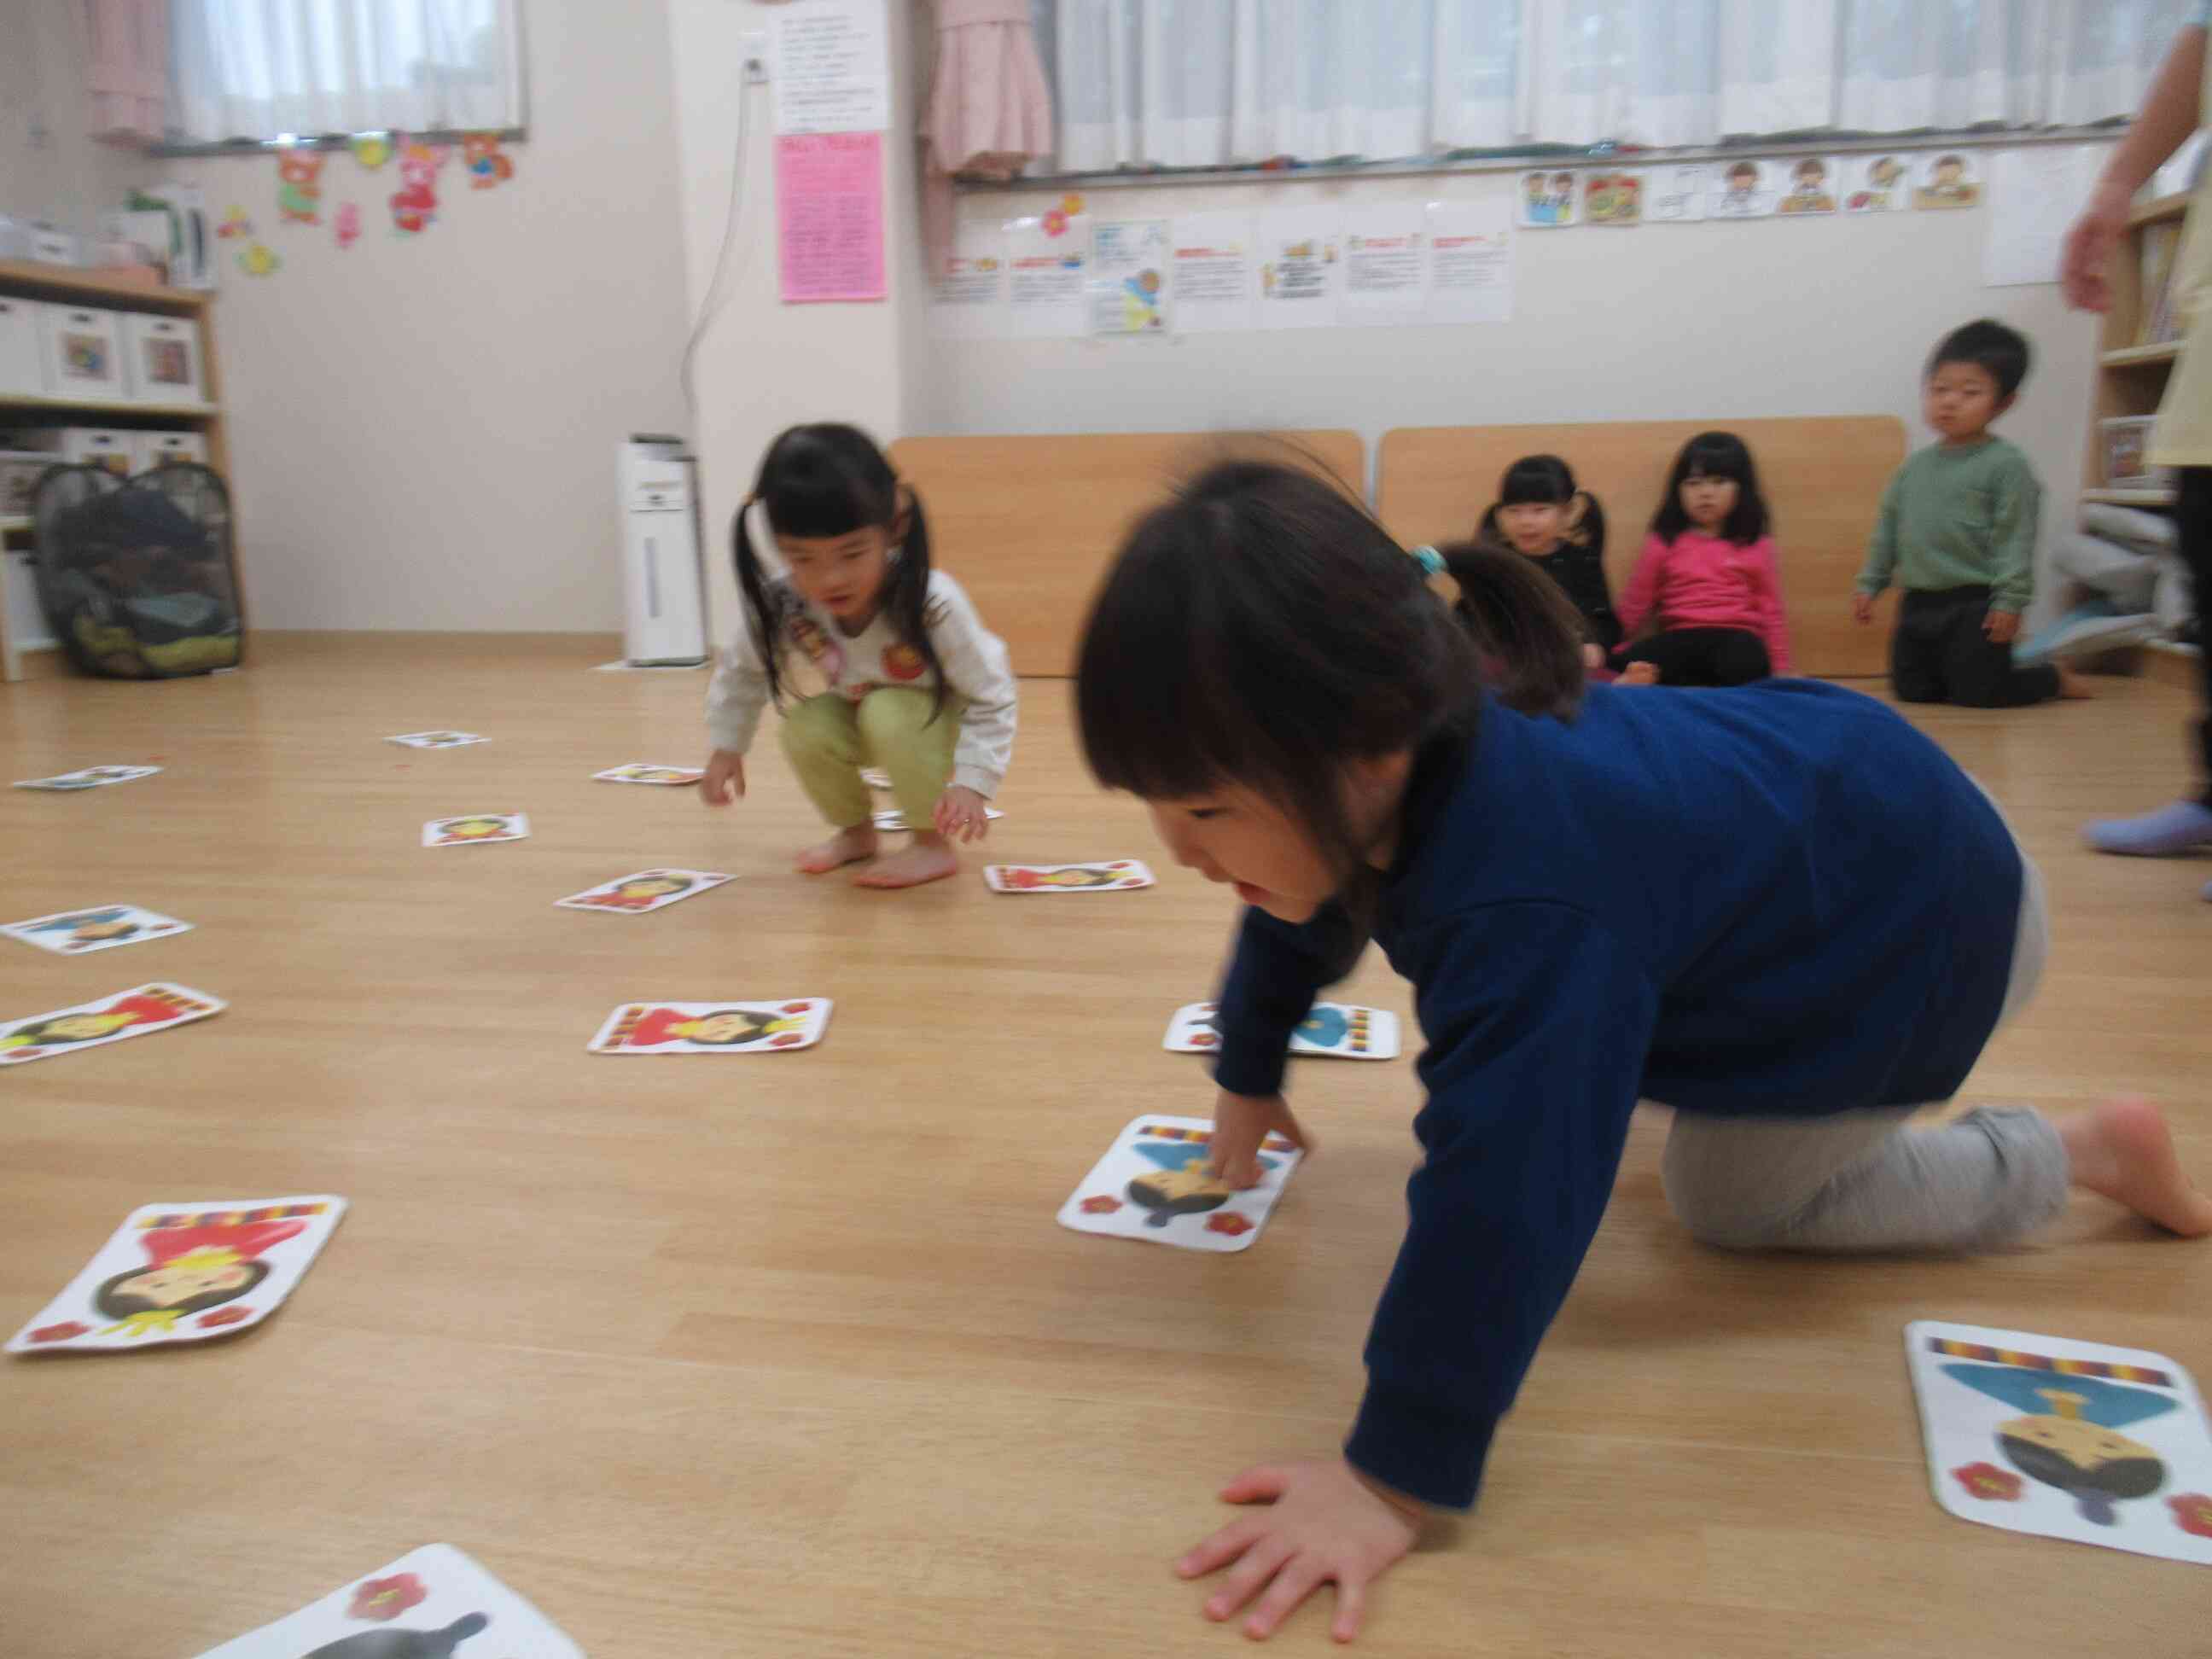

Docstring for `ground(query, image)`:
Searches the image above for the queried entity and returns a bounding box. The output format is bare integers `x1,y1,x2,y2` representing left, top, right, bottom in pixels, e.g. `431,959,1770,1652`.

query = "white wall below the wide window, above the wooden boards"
911,172,2095,623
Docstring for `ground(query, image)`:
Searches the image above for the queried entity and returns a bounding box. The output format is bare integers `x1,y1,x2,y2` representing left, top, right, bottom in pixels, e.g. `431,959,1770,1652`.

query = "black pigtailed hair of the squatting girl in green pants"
732,422,946,719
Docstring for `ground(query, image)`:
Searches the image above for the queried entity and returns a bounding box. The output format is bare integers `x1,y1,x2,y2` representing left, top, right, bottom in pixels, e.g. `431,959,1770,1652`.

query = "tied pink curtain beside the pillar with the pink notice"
923,0,1053,274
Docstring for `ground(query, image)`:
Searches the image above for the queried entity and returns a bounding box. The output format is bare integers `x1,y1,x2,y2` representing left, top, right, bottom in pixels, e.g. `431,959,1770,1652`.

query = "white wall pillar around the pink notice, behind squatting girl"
668,0,924,637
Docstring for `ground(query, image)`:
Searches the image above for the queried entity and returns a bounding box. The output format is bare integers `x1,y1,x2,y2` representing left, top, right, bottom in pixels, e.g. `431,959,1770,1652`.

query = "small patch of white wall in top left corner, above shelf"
0,0,148,235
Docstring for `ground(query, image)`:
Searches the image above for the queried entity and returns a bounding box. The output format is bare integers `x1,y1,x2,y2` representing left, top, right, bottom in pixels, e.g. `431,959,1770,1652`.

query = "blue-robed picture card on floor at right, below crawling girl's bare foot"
1905,1320,2212,1566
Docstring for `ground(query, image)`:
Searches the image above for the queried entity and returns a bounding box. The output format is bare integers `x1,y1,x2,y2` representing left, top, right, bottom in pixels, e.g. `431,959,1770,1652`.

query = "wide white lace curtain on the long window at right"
1033,0,2197,171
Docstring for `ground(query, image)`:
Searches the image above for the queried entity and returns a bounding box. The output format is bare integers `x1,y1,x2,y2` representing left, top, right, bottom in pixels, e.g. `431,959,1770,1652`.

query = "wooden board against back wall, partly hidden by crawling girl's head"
892,431,1367,675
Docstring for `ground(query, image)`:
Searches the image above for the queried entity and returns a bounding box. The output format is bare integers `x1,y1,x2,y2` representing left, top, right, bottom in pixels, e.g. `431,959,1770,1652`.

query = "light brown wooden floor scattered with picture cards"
0,637,2212,1659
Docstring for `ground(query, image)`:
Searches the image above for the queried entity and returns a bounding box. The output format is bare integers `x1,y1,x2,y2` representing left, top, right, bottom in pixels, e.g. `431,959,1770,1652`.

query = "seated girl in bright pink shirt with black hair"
1619,431,1790,686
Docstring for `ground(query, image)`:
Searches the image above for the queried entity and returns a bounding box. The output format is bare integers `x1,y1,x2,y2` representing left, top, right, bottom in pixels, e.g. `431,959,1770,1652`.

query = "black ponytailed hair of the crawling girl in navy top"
1075,460,1581,902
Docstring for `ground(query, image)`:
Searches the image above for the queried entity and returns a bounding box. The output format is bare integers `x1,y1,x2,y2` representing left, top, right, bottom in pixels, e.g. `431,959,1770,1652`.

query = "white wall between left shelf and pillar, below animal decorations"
161,0,684,631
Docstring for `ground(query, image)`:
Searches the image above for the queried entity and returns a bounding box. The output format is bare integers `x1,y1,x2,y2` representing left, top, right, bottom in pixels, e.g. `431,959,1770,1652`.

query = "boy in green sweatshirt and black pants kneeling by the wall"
1852,318,2088,707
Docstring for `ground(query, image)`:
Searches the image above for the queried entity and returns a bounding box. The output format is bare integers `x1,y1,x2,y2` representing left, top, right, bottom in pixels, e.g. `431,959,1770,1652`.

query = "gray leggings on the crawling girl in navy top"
1666,852,2069,1252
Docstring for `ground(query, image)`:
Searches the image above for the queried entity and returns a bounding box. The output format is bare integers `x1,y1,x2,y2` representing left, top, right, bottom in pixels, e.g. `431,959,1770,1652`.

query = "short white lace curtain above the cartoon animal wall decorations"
171,0,524,143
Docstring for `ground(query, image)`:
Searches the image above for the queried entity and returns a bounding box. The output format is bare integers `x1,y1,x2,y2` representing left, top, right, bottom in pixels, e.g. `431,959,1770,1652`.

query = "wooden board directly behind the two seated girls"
1378,416,1905,679
